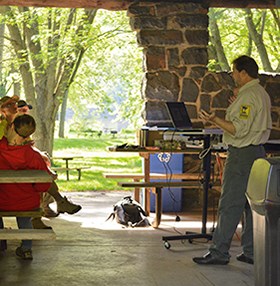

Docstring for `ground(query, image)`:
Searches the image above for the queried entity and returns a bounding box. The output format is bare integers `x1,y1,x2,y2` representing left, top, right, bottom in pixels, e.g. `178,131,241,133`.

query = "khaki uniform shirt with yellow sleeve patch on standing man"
223,79,272,148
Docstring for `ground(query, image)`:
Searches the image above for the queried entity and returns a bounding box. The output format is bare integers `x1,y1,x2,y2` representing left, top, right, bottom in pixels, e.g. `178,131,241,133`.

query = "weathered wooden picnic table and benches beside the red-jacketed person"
0,170,56,250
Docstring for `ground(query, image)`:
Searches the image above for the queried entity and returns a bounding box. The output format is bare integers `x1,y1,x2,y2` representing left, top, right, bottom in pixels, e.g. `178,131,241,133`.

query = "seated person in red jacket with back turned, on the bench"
0,115,51,260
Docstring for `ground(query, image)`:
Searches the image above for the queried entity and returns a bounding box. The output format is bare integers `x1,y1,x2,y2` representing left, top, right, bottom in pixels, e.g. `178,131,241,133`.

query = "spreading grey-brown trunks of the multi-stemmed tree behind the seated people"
0,6,96,155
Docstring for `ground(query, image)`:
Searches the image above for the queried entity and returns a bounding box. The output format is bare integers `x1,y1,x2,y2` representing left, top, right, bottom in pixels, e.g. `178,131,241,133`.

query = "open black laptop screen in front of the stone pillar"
165,102,192,130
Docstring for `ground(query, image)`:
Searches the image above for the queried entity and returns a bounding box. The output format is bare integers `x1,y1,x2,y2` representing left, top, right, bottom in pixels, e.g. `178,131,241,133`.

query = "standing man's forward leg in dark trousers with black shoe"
193,146,259,264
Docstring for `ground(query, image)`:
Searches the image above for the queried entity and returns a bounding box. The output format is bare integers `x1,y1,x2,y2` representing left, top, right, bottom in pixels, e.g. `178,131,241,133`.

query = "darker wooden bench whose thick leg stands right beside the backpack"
118,181,200,228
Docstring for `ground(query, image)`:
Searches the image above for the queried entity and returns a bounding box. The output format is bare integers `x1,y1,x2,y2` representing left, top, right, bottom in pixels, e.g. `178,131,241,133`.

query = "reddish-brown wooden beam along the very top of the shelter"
0,0,280,11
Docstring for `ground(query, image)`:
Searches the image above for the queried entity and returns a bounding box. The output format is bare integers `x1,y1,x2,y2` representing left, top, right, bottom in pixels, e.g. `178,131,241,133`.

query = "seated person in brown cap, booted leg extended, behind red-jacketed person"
0,95,81,229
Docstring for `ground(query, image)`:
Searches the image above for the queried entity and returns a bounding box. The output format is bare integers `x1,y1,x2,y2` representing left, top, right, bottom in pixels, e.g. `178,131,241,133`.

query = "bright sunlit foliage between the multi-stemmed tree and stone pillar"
67,10,143,131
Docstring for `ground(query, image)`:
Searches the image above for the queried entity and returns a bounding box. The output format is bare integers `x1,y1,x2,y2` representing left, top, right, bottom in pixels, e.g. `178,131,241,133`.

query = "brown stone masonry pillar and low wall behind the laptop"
128,2,280,138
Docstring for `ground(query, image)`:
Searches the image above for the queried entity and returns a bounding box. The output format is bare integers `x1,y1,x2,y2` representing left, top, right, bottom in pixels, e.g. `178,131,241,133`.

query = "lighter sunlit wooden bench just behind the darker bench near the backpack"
103,173,200,202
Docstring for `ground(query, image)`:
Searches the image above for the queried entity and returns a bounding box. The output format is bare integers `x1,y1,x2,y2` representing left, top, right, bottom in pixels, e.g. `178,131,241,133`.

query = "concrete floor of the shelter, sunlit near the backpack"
0,192,254,286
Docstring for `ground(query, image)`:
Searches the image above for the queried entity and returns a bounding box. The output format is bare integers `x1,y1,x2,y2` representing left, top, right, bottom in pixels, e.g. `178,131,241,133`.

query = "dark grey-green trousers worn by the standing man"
209,145,265,259
